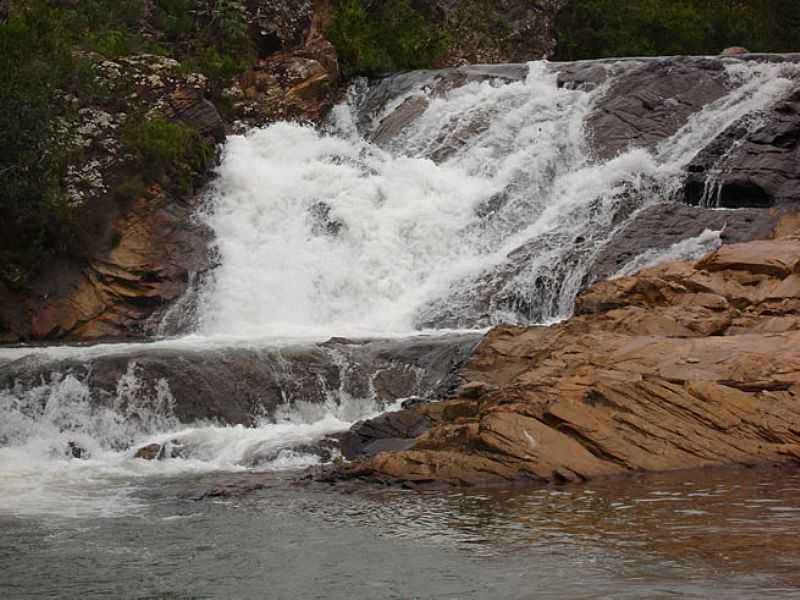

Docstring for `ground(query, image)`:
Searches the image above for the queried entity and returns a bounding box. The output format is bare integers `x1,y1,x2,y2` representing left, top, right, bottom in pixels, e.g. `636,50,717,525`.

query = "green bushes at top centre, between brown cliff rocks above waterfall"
328,0,447,77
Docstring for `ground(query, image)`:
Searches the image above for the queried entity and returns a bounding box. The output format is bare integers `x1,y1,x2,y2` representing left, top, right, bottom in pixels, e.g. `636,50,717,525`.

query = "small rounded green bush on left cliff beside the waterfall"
121,116,213,191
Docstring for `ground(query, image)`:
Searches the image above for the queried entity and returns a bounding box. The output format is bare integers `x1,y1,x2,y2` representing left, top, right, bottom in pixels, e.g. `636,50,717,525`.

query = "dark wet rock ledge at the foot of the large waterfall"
0,334,480,426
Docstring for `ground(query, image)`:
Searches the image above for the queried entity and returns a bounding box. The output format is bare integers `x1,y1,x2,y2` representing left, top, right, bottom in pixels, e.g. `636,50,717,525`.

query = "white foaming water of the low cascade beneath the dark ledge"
0,364,393,518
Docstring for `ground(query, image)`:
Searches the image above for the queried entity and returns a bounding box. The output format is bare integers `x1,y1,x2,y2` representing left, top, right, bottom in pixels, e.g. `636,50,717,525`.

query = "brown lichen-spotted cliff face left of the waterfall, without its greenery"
0,0,339,342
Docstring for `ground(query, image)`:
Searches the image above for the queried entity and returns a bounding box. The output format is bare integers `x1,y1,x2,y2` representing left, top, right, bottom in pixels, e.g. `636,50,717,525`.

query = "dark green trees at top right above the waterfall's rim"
556,0,800,60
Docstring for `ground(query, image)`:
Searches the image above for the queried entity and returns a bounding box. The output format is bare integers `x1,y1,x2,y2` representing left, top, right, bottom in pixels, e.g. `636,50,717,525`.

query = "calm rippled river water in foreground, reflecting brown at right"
0,471,800,600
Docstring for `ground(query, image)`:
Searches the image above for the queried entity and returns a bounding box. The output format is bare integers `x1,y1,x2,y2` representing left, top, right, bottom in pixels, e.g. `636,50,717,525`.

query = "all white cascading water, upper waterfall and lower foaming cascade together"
0,58,797,514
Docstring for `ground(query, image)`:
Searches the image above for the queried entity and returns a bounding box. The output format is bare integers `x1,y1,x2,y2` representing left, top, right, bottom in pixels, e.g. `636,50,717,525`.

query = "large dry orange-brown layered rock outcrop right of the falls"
329,226,800,485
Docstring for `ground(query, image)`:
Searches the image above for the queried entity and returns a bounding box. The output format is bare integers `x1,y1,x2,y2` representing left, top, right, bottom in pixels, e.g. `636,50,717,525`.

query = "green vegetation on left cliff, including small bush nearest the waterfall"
0,0,250,285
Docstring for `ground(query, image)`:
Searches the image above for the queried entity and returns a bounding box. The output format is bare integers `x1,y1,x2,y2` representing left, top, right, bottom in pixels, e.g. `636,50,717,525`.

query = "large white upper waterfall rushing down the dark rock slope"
199,62,793,338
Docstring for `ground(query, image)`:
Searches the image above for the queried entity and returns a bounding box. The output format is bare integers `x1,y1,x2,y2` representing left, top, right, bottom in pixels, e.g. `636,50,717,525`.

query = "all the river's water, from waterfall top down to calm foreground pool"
0,58,800,599
